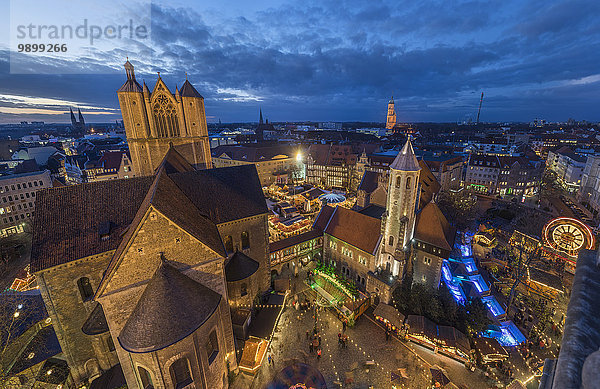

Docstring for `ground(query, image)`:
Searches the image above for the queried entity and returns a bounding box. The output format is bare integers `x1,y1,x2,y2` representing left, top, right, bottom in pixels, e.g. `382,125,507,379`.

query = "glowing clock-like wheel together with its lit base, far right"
542,217,595,273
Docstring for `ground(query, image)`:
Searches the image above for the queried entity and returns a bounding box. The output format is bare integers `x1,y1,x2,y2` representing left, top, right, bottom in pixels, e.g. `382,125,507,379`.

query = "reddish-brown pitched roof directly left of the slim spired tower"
325,207,381,254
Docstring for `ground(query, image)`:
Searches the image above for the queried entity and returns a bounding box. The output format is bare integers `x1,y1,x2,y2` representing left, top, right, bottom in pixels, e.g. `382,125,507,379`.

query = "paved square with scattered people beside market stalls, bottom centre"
233,266,492,389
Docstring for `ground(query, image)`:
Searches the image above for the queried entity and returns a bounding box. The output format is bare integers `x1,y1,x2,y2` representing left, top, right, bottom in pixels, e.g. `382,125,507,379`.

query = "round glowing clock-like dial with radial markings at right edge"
544,217,594,257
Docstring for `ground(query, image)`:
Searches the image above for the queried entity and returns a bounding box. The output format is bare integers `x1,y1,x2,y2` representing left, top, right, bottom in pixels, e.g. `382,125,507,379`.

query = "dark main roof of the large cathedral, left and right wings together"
31,150,267,272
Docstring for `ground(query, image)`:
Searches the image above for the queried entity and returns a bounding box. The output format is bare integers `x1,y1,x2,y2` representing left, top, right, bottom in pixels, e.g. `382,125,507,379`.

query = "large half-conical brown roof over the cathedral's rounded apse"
118,261,221,353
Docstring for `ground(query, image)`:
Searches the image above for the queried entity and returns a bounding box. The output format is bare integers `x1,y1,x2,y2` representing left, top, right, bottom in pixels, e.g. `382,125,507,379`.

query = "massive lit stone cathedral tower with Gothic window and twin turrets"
117,61,212,176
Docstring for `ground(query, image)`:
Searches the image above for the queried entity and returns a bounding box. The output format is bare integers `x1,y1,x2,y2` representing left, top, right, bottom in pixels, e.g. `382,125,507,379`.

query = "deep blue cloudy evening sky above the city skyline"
0,0,600,123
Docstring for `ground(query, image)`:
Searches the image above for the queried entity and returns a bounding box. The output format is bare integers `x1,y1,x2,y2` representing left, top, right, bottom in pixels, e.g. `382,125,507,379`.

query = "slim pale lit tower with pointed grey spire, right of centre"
377,137,421,277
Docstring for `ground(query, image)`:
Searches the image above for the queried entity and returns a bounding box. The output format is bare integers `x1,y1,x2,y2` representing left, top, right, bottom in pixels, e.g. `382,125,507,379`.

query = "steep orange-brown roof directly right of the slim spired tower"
415,201,456,251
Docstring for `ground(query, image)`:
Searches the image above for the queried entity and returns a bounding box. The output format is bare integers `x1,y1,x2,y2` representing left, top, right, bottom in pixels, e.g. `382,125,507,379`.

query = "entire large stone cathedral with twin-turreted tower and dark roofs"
31,61,270,389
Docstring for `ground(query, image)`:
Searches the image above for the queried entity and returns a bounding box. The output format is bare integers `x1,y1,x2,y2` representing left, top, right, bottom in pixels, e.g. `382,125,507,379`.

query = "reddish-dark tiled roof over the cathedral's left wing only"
31,177,154,272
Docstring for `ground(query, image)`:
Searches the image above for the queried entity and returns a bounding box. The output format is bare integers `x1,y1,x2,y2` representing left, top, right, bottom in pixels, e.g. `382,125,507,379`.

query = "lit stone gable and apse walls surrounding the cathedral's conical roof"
98,207,236,388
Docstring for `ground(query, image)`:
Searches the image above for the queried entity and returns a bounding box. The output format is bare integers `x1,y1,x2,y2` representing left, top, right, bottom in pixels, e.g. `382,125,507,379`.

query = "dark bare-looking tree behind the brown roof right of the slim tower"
436,190,477,230
